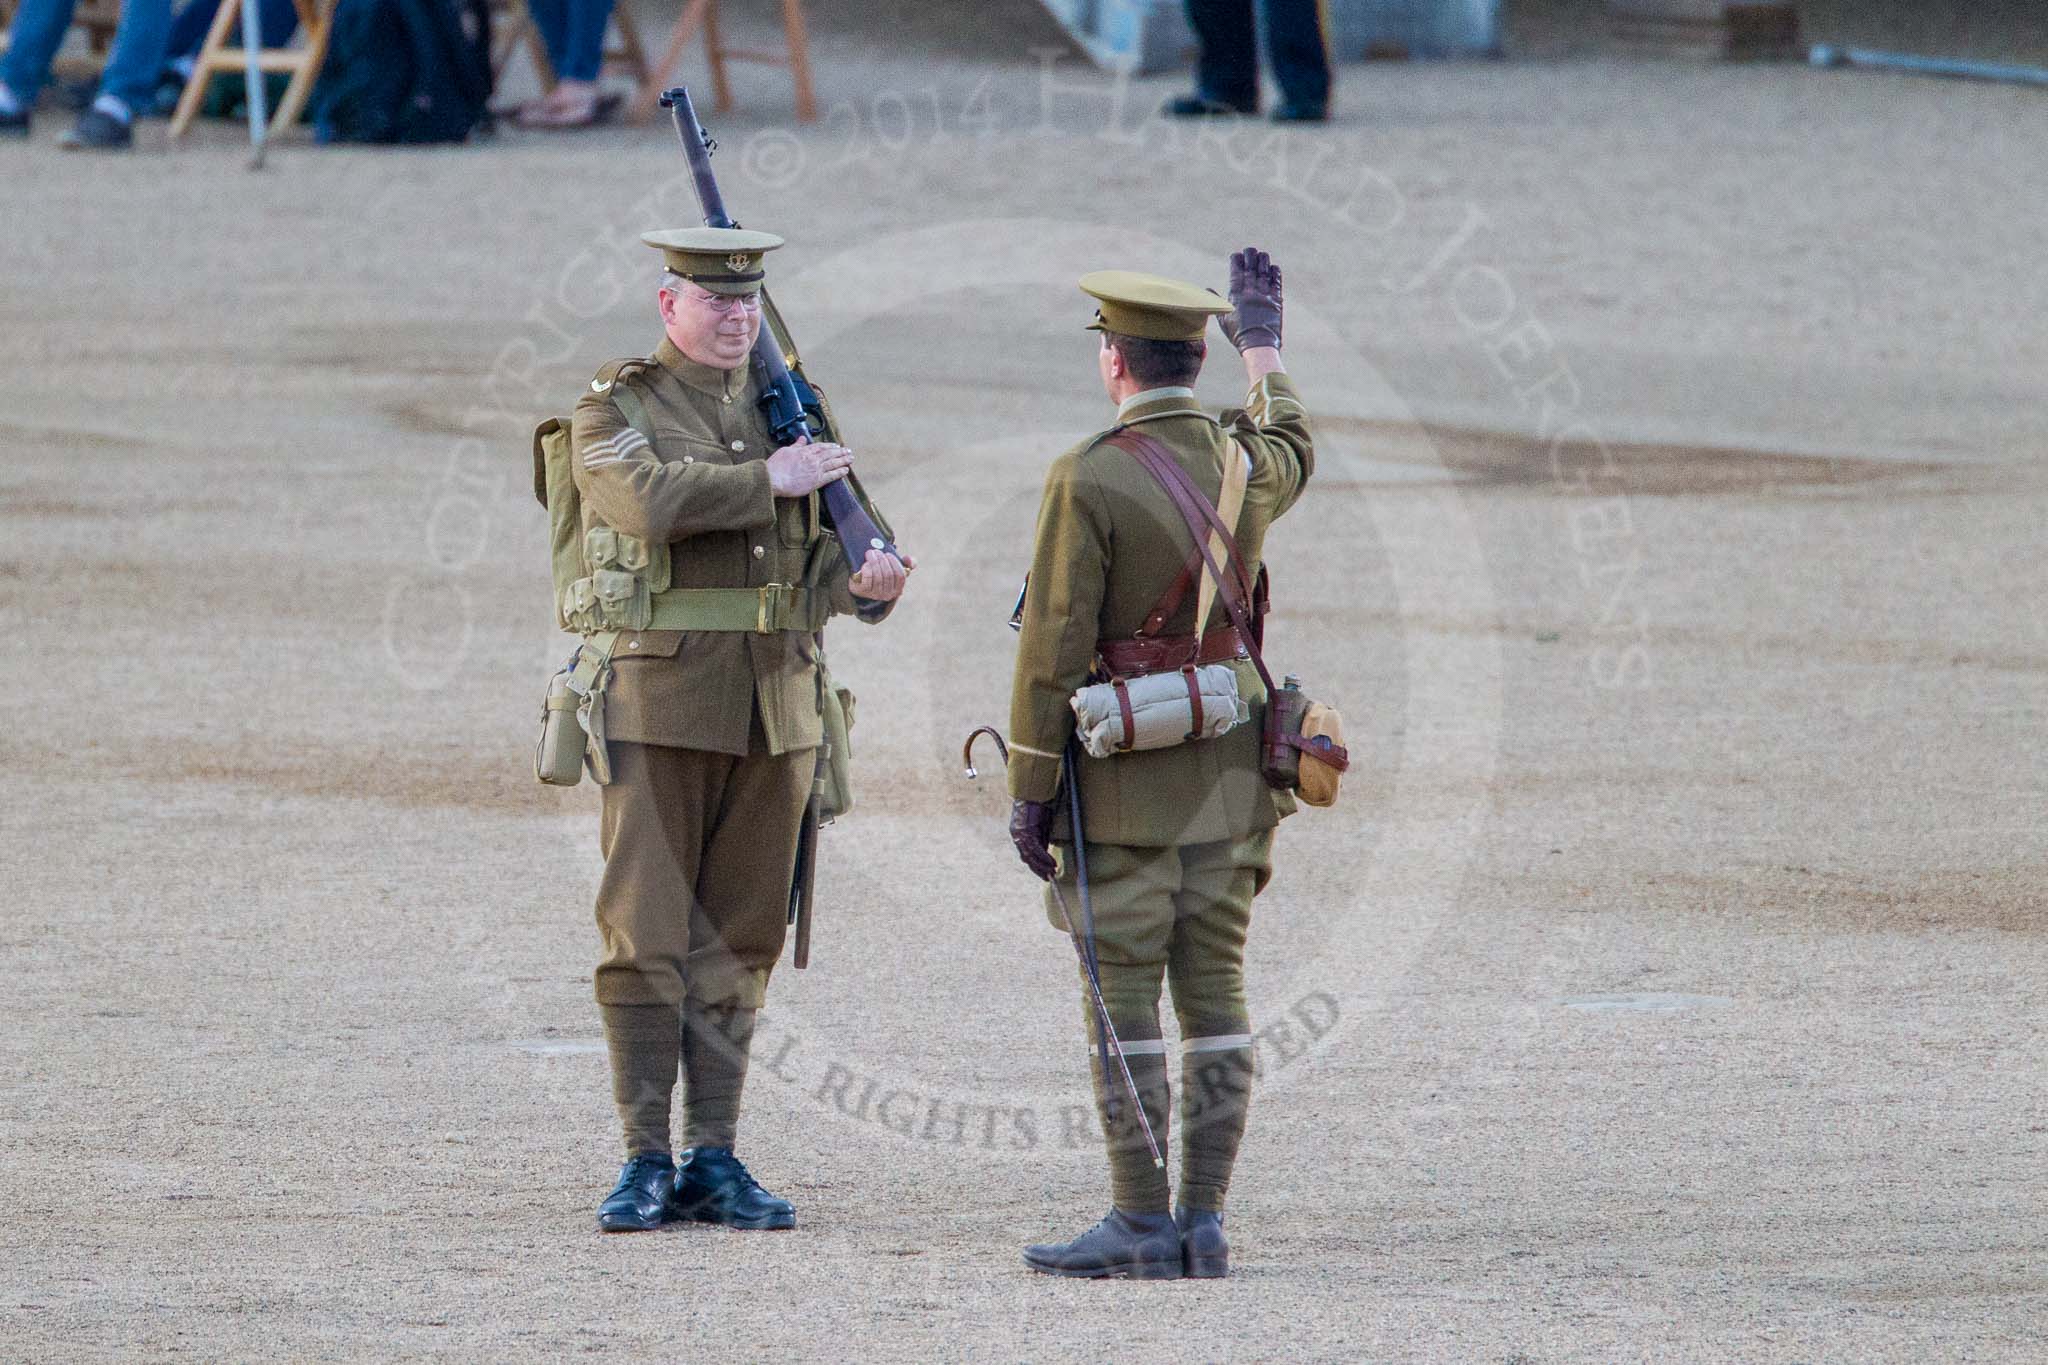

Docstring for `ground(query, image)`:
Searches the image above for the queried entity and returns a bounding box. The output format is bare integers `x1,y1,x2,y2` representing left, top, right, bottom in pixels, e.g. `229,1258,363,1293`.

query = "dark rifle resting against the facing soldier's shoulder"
662,86,897,573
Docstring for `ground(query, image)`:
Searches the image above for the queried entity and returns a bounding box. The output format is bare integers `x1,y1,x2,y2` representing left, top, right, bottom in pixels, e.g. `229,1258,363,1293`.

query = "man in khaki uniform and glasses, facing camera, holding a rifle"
571,227,911,1232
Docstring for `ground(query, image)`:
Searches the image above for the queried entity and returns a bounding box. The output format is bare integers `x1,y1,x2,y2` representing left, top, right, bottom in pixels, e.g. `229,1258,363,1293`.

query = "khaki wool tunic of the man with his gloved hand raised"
1010,372,1315,847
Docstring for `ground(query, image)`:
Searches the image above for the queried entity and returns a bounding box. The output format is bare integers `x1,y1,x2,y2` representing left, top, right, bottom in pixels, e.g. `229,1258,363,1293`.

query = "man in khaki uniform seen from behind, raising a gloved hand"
1010,248,1315,1279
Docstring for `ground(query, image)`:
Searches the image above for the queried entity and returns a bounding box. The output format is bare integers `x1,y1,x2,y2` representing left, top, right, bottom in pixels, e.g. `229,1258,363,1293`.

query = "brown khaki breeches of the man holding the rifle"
594,736,817,1009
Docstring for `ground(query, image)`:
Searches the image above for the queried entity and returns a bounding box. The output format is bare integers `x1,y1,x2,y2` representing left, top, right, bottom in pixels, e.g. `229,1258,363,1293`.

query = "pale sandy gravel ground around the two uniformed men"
0,5,2048,1363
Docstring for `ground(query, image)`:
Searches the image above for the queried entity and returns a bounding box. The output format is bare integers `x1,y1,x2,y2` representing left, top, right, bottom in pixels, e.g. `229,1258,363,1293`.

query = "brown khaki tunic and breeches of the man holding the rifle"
571,340,893,1009
